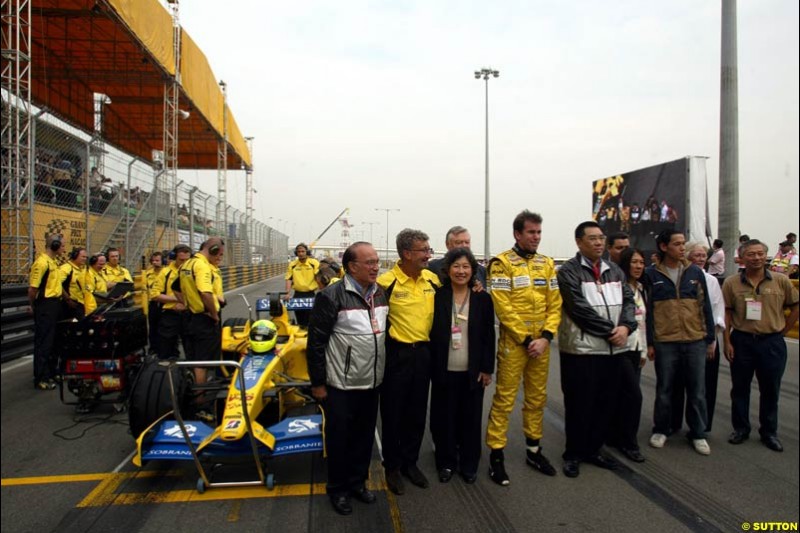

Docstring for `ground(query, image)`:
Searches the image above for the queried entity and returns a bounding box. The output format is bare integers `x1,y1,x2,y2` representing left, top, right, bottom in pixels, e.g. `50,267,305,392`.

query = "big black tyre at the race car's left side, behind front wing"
128,360,189,439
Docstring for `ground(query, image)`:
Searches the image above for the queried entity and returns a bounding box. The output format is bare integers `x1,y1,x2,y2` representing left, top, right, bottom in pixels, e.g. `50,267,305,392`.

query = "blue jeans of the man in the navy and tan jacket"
653,341,708,439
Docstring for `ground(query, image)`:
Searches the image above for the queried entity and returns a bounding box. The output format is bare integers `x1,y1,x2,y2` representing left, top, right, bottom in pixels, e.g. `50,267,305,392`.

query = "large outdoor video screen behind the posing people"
592,158,688,263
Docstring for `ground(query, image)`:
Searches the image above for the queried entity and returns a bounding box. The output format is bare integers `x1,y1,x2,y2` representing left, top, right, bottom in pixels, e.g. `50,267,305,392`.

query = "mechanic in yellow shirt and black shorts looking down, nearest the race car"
177,237,225,386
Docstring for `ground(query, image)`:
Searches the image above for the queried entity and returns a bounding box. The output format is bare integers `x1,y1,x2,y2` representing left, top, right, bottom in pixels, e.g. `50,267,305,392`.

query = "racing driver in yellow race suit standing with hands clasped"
486,210,561,485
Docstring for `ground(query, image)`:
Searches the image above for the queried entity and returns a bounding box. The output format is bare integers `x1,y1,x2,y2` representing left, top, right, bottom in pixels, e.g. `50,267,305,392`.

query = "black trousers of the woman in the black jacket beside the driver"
431,372,483,475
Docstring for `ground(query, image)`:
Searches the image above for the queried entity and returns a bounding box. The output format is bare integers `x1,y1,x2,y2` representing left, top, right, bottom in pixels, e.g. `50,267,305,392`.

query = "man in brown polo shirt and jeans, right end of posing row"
722,239,798,452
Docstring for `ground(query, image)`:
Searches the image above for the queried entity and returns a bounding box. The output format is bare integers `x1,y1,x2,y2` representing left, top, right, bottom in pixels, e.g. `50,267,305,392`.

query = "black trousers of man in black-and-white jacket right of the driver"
560,353,623,461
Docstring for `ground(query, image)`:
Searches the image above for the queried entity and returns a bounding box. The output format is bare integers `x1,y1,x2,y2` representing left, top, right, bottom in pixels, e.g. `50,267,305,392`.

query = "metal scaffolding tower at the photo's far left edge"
0,0,35,272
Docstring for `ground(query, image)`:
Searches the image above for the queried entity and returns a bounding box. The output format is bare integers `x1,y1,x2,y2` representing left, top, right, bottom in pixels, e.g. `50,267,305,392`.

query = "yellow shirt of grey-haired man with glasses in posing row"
378,261,441,343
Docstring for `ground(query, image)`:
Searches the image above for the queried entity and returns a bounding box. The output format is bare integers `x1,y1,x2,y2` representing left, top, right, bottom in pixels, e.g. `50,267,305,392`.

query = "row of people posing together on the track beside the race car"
286,210,798,515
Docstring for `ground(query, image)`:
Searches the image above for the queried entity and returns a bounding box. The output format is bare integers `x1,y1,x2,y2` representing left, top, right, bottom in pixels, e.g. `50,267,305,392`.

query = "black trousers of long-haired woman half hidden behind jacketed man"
606,352,642,450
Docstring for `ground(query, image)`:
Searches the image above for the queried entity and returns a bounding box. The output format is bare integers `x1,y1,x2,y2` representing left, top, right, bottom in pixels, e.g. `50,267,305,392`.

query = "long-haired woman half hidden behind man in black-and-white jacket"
606,248,648,463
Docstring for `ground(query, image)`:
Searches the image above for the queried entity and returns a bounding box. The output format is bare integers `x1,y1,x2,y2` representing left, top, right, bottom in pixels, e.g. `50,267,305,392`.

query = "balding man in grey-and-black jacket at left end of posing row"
307,242,389,515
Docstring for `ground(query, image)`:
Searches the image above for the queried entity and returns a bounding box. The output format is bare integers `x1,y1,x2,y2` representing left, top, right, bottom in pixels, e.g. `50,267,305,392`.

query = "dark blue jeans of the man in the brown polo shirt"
731,330,786,437
